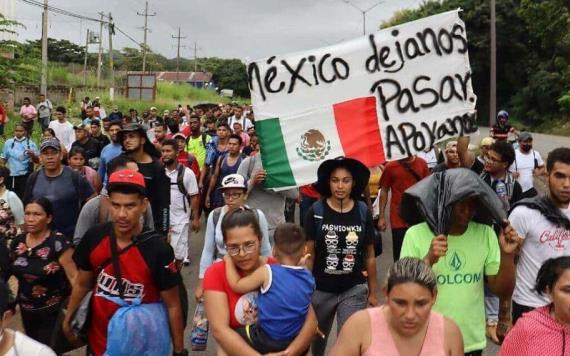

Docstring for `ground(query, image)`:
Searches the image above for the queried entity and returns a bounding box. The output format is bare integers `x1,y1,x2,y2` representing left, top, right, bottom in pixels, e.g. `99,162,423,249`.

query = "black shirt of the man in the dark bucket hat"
138,160,170,236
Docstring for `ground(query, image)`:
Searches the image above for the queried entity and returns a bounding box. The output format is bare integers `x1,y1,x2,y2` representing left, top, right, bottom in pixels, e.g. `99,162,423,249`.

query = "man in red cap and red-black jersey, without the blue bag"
63,170,188,356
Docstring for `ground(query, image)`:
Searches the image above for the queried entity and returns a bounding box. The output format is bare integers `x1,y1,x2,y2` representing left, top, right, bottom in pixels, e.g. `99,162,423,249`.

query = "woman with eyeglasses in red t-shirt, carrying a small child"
204,207,317,355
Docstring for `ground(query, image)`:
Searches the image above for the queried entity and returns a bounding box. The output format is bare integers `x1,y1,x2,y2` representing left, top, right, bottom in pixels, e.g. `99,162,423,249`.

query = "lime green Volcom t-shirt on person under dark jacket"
400,222,501,352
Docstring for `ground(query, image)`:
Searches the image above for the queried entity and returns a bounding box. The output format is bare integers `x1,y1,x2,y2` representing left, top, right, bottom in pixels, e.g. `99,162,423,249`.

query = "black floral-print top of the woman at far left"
10,232,71,310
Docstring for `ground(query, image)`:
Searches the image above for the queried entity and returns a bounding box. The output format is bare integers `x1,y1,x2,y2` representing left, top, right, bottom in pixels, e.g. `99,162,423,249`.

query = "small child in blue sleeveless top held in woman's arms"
224,223,315,354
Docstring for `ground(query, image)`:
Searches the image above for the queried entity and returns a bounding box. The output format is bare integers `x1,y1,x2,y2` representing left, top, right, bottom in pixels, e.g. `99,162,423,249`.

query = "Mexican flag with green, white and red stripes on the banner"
255,96,386,188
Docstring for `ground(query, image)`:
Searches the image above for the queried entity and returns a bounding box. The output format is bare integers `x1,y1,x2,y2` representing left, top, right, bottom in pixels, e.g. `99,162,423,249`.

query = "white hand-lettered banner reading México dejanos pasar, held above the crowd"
247,10,477,164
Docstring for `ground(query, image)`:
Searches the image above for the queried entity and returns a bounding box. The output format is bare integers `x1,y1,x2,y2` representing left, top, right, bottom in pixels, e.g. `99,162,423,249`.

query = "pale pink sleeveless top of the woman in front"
362,306,445,356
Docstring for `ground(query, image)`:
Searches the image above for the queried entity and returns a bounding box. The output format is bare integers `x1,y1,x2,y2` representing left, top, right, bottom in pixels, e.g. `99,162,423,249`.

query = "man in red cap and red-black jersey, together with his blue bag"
63,170,188,356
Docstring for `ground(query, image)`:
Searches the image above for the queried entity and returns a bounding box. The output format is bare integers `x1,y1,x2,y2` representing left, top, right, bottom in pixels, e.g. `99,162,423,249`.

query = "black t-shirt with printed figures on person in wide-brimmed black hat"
305,201,374,293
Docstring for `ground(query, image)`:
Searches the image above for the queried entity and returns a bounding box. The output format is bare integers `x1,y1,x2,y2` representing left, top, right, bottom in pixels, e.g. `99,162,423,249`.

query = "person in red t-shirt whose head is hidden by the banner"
378,156,429,261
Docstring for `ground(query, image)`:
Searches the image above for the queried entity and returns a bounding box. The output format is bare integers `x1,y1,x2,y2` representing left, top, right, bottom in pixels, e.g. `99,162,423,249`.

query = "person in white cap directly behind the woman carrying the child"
194,174,271,301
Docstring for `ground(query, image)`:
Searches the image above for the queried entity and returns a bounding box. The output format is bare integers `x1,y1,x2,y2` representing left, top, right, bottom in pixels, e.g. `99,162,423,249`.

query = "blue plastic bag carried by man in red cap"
105,297,171,356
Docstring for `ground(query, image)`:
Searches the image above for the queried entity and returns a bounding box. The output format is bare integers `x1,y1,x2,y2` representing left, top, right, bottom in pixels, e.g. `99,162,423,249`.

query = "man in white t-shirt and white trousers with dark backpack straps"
162,139,200,268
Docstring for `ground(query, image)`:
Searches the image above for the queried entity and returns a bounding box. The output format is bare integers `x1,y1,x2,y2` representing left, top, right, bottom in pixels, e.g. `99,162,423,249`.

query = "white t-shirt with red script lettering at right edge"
509,206,570,308
